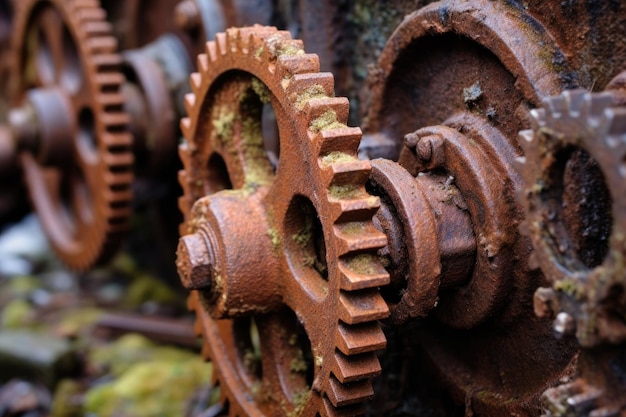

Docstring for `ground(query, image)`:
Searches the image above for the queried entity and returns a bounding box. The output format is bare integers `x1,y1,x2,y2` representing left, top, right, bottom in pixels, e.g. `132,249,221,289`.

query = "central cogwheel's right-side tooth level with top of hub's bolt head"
333,222,387,256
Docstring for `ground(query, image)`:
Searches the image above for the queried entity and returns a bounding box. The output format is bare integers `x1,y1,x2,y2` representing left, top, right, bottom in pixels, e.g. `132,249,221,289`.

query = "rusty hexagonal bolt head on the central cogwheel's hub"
176,233,213,290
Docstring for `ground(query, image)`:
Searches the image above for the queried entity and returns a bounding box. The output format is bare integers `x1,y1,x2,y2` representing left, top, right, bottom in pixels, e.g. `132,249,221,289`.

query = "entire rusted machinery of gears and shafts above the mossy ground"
0,0,626,417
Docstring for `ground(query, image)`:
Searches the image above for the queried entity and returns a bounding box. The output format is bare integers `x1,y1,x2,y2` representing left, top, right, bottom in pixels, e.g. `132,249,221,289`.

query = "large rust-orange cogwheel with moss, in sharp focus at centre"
177,26,389,416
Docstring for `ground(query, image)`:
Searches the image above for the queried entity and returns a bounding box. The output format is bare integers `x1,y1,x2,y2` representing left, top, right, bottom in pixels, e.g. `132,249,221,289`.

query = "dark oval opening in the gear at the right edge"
542,147,613,270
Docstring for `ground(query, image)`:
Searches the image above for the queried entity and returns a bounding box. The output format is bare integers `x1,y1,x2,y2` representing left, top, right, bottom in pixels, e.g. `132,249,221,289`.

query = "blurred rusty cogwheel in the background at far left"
11,0,133,270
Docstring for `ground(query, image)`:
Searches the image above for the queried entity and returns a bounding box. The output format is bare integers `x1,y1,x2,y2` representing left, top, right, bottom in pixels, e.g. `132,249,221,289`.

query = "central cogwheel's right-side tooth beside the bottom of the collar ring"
339,290,389,324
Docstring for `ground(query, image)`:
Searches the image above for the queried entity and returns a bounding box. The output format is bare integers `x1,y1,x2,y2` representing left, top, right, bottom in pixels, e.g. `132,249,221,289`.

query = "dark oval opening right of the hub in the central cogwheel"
284,196,328,297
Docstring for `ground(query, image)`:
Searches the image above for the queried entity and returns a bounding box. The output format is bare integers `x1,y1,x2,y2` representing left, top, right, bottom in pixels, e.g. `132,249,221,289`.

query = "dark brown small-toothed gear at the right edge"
520,90,626,347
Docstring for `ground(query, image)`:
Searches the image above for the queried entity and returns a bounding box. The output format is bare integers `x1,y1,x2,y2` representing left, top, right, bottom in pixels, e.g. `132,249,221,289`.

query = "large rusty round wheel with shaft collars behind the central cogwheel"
361,0,577,417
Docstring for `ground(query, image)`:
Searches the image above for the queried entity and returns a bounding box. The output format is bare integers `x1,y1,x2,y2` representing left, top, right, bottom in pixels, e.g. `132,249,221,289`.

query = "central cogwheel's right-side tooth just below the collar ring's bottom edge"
337,321,387,355
